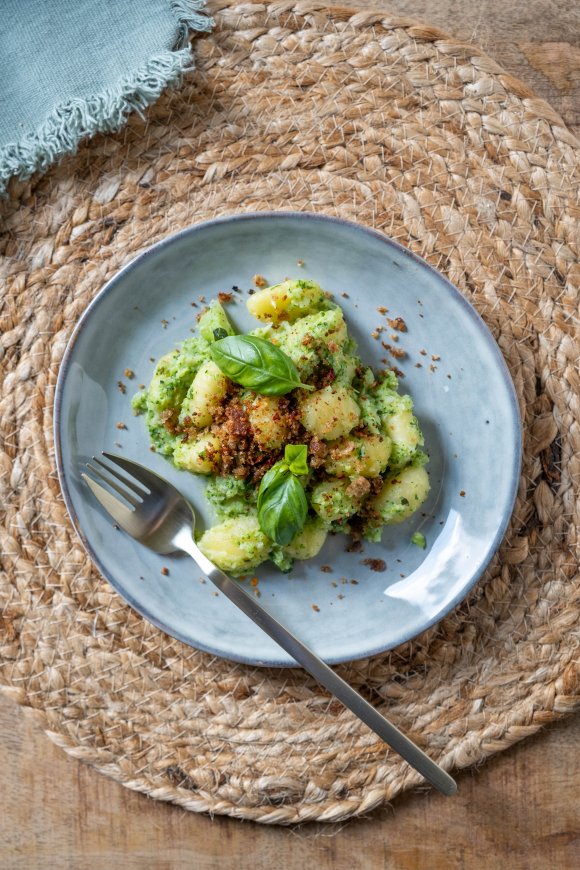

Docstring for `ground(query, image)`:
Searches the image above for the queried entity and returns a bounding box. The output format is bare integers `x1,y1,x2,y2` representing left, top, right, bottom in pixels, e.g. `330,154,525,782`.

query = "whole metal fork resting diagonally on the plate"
82,453,457,795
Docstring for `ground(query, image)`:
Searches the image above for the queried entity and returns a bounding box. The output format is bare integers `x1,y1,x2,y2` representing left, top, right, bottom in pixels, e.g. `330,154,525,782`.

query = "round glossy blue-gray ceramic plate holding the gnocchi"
55,212,520,665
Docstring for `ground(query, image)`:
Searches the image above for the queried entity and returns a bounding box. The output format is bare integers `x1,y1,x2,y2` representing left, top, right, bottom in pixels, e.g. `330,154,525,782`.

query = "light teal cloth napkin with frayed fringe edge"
0,0,212,193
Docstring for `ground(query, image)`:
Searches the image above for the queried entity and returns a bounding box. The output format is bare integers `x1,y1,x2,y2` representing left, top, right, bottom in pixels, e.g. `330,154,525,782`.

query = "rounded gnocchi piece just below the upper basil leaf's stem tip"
300,386,360,441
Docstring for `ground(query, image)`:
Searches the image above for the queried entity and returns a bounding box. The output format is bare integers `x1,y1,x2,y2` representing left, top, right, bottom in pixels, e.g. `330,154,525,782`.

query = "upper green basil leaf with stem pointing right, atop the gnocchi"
210,335,314,396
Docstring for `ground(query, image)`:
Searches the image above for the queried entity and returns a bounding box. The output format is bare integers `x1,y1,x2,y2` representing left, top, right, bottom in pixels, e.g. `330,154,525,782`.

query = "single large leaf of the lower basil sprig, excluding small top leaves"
258,473,308,547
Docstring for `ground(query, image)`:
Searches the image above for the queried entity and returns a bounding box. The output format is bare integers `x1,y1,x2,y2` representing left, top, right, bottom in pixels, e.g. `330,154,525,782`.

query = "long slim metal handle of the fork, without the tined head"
180,540,457,795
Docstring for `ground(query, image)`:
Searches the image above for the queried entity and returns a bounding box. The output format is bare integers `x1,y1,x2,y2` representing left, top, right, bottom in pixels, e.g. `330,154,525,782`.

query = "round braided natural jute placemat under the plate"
0,2,580,823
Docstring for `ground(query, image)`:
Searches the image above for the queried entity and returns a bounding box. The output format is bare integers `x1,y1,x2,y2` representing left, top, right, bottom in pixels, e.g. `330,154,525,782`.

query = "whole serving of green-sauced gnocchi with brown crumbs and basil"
133,280,429,575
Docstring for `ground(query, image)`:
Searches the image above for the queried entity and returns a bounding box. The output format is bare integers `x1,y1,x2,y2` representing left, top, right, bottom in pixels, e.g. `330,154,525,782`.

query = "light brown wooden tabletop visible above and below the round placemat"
0,0,580,870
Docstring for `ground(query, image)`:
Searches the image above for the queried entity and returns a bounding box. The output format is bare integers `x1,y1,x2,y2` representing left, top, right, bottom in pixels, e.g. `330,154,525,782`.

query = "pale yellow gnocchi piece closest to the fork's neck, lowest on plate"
197,516,272,574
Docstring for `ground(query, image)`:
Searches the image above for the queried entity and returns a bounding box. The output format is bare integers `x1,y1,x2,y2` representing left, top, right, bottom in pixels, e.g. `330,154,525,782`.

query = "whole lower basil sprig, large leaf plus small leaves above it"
258,444,308,547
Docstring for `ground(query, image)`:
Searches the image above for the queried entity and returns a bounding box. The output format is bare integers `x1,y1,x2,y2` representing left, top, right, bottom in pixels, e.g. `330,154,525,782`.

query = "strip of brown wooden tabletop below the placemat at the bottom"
0,696,580,870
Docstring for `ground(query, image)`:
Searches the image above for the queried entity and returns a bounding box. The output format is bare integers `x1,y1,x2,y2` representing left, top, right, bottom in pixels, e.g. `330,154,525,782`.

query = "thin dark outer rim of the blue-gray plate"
52,209,523,668
